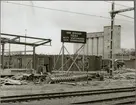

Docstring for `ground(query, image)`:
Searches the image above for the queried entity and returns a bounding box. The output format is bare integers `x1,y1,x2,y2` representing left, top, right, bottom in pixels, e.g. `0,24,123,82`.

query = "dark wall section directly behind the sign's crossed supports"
53,55,102,71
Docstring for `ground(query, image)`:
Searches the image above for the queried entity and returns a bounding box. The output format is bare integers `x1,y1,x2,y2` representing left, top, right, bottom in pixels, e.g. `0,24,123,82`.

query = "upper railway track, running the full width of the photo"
1,87,136,104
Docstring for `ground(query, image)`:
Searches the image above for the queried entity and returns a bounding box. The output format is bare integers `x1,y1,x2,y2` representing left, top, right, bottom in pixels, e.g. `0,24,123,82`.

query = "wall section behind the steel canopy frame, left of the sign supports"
4,55,52,72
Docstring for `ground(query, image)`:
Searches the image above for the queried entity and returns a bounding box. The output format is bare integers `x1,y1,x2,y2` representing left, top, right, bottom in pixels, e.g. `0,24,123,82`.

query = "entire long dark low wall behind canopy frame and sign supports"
4,54,101,72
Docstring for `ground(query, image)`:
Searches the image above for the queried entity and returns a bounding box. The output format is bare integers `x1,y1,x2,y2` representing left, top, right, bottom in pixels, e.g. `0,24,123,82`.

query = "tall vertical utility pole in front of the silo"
110,2,115,76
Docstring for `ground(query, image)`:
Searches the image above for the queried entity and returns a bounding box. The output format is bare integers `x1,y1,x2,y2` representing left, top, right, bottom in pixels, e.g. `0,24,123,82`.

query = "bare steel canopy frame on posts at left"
0,33,52,70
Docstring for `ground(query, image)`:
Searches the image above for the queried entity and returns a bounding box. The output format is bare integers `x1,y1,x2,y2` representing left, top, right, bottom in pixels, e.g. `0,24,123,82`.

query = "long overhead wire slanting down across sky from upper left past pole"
4,1,133,22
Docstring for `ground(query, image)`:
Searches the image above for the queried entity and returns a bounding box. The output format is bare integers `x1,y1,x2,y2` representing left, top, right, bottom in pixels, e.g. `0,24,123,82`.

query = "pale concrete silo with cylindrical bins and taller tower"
73,25,121,59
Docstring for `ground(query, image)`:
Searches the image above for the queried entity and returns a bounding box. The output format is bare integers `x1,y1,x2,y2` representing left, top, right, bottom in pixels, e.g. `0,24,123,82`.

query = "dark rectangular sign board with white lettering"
61,30,86,44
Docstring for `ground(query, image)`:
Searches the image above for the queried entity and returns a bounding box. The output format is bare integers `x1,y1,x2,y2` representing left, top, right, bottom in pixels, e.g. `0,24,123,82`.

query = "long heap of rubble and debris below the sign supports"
0,73,104,85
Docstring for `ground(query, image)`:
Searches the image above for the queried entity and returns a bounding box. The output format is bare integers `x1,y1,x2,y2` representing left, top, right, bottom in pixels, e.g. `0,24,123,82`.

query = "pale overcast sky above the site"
1,1,134,54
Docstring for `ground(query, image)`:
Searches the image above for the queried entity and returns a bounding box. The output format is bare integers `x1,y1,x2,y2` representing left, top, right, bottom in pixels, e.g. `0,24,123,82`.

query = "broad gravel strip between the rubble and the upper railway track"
0,80,135,96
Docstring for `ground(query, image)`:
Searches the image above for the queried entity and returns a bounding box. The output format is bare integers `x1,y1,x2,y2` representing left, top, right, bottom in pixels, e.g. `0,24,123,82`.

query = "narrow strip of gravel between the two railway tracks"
0,92,134,105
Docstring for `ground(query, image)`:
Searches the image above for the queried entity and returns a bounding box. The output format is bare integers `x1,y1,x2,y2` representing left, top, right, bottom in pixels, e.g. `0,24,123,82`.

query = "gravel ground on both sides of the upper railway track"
0,79,135,105
